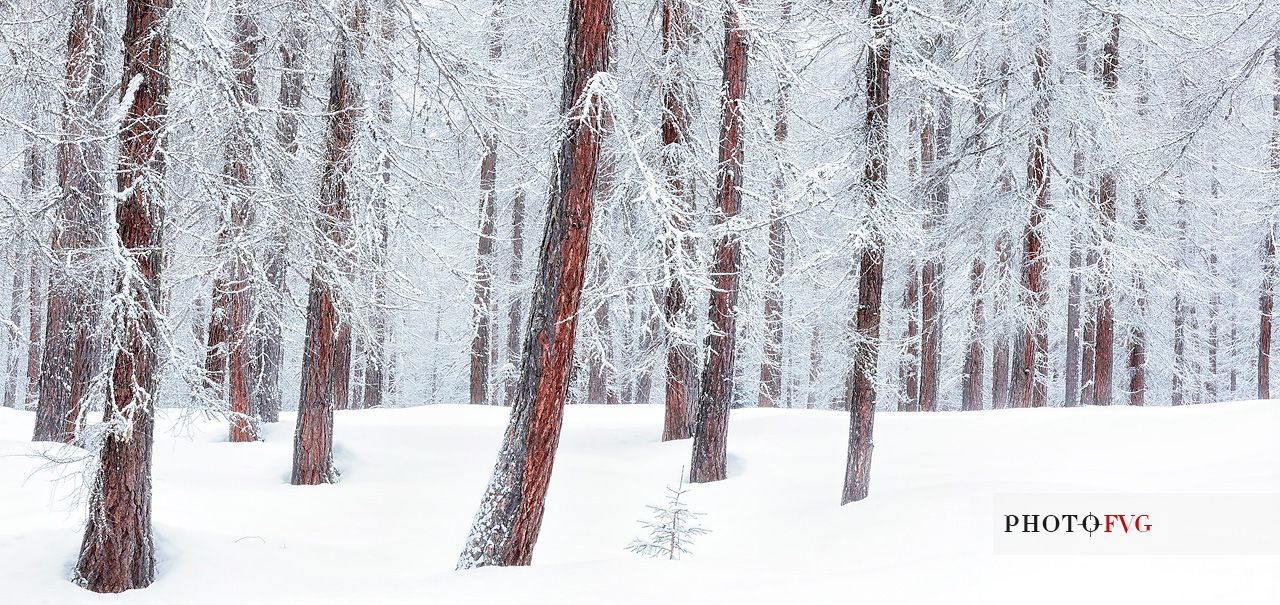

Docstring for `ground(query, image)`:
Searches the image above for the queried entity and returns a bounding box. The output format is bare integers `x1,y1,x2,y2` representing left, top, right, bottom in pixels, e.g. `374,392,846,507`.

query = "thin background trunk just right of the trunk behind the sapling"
758,0,791,408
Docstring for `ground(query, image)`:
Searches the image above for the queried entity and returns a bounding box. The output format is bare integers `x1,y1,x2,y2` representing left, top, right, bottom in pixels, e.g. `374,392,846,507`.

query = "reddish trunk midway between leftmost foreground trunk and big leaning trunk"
292,6,365,485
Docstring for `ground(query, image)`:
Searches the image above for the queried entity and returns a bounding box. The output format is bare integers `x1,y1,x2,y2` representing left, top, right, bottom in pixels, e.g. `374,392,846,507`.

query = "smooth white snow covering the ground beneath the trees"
0,402,1280,605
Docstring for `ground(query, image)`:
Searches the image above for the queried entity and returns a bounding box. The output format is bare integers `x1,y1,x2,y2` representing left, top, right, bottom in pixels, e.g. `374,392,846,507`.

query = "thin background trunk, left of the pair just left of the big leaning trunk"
471,0,502,405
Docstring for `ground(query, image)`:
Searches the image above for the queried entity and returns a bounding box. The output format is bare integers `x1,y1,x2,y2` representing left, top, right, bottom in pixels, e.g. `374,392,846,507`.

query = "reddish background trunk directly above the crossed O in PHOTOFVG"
1093,14,1120,405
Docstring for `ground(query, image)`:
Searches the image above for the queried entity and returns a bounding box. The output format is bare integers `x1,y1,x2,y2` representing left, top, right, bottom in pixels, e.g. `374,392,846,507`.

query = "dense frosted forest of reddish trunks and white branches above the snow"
0,0,1280,602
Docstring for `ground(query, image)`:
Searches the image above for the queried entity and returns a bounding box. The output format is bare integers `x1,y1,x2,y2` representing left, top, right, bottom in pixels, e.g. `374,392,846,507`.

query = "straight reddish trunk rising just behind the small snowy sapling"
689,0,748,483
